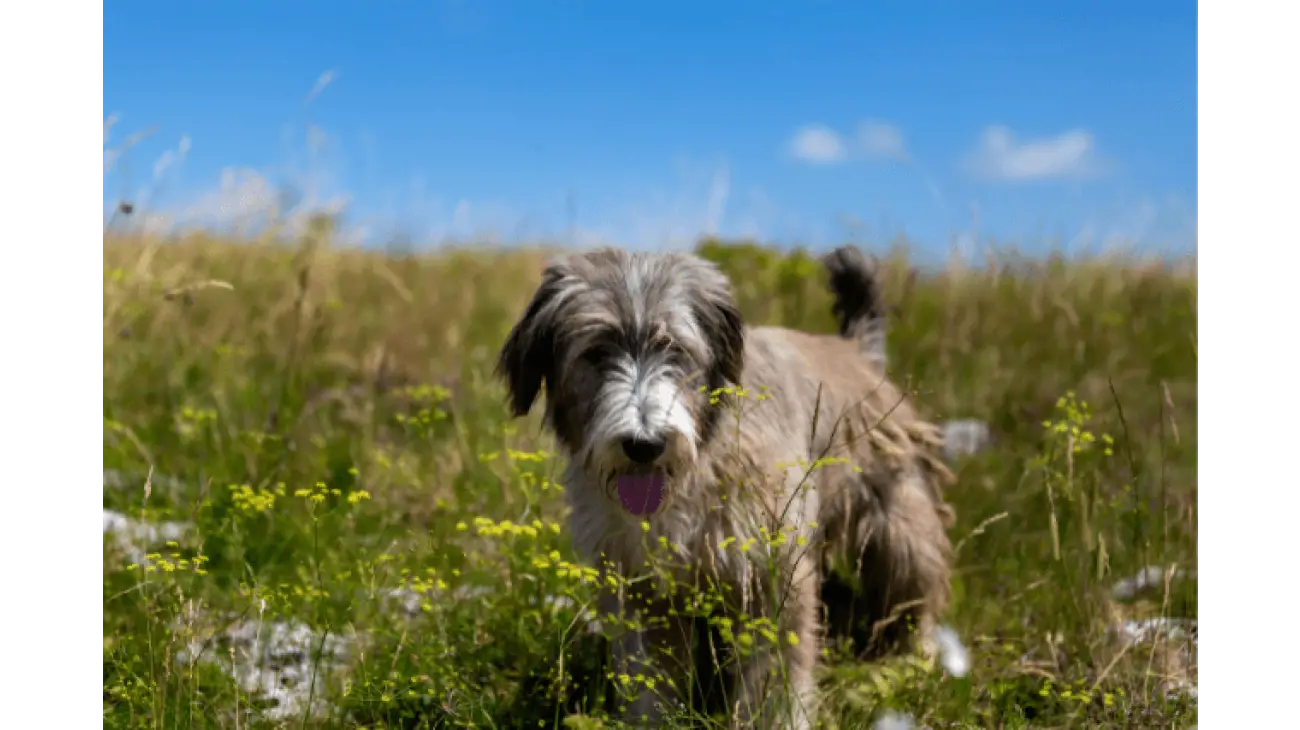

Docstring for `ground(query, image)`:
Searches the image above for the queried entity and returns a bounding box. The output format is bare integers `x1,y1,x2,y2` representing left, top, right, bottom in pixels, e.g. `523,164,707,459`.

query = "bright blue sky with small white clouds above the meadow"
103,0,1199,252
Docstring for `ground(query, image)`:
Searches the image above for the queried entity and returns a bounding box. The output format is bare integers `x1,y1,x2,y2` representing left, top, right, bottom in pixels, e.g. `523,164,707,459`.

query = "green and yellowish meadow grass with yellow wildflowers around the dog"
103,230,1197,727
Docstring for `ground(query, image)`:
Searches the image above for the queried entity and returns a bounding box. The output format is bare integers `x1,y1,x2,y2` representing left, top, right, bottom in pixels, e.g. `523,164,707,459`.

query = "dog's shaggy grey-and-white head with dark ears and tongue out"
498,249,745,516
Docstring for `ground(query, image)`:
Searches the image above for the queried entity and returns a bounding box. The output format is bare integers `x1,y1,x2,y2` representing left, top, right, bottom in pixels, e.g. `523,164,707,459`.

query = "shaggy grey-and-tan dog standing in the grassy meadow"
497,242,952,729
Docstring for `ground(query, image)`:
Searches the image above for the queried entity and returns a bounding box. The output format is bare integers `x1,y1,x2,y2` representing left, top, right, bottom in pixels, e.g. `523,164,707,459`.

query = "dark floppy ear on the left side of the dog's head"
497,264,566,417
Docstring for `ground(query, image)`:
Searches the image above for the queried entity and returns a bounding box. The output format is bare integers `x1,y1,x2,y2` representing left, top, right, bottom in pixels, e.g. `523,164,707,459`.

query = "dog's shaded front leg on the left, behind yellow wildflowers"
602,595,692,727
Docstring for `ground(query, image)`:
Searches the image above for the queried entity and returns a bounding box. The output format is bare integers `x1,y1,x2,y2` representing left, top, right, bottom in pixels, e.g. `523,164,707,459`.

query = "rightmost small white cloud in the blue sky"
969,126,1104,182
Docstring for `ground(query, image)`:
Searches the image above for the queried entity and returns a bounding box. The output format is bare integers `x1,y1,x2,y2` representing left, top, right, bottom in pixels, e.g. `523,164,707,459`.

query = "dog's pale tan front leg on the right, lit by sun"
735,556,819,730
